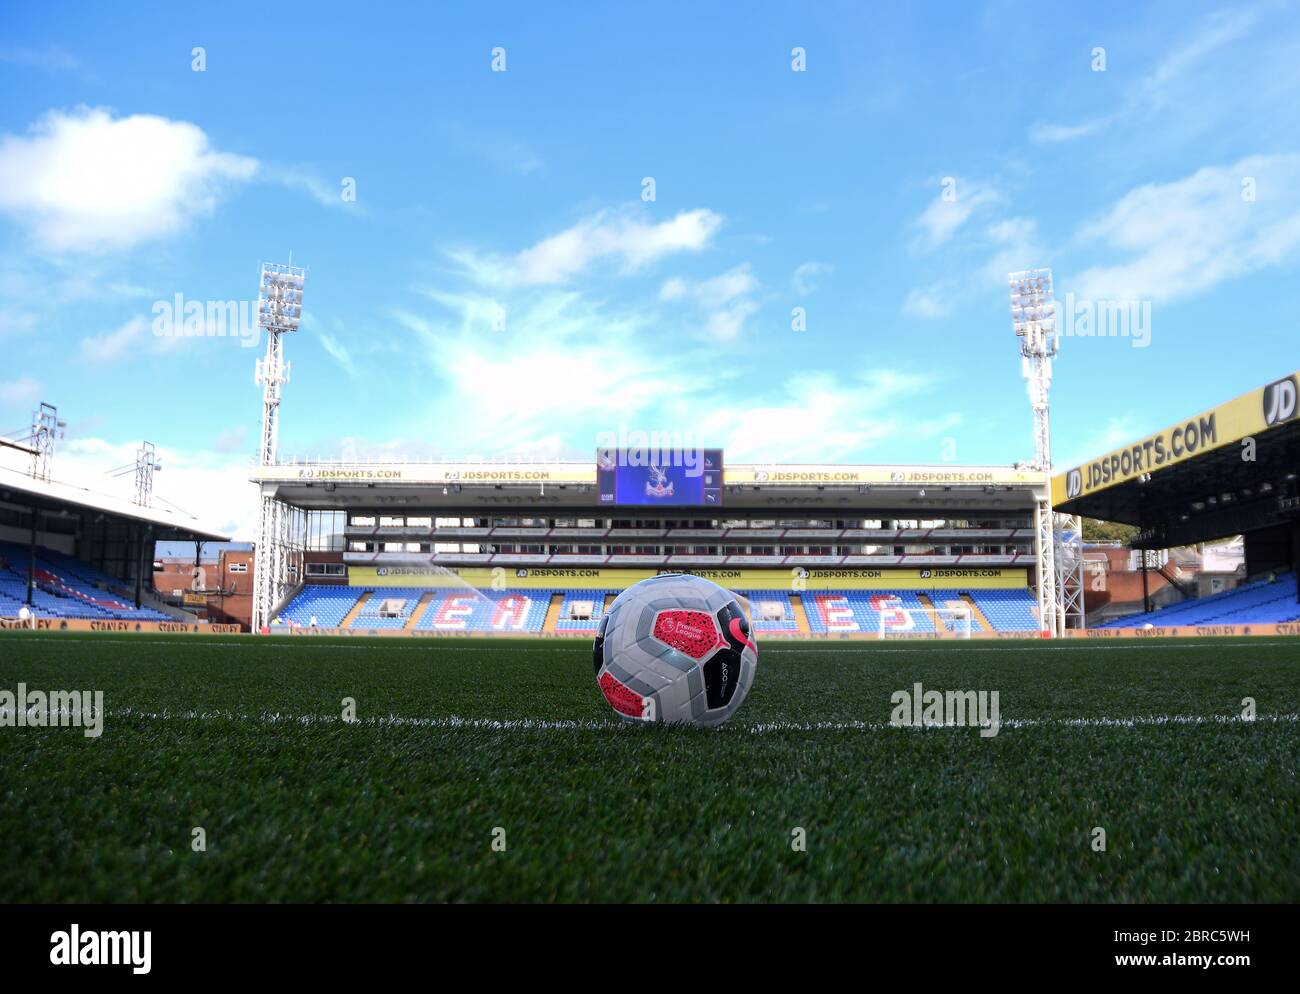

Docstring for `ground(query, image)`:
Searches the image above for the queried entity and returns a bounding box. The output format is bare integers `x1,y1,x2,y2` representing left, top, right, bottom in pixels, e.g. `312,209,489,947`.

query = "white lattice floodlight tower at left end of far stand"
252,262,307,631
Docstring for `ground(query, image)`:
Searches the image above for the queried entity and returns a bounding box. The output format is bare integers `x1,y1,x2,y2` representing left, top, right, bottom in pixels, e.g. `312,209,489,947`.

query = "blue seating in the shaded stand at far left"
0,542,173,621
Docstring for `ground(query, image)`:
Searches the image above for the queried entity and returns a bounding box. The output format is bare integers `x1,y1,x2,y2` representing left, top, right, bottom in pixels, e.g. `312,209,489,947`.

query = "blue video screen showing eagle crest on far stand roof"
595,448,723,507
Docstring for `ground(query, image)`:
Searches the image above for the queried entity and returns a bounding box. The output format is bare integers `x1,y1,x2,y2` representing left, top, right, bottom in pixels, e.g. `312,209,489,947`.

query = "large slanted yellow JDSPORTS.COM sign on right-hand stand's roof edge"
1052,373,1300,505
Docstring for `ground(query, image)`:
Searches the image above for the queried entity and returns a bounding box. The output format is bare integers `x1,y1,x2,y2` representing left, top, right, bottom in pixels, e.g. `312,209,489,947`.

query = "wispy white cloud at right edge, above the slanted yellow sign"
1058,155,1300,301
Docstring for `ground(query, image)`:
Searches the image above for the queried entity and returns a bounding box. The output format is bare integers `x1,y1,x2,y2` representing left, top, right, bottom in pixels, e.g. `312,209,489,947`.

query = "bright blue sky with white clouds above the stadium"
0,3,1300,534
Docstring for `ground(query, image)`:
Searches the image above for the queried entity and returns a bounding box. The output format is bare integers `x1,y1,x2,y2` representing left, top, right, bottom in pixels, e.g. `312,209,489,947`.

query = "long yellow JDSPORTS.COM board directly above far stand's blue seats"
347,567,1028,591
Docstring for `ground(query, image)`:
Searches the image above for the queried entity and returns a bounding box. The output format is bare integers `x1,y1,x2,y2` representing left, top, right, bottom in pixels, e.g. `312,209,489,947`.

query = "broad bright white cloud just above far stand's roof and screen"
395,266,961,460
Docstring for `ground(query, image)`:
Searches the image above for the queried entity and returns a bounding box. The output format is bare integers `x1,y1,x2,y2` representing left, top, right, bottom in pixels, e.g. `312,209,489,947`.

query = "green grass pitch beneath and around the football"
0,633,1300,902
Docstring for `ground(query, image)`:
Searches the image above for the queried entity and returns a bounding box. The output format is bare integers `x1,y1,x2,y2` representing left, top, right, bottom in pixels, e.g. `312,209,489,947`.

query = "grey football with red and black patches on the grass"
593,573,758,725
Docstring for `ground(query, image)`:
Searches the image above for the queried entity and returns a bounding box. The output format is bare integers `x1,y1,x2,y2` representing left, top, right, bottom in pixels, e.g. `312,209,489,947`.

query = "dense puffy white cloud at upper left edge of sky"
0,108,257,251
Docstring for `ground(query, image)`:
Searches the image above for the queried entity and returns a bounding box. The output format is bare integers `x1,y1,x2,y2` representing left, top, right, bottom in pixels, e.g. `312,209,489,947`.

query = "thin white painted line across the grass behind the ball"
96,707,1300,735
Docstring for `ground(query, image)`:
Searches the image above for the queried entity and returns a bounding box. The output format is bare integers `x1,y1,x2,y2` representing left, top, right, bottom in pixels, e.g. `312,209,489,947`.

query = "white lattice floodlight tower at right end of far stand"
1008,269,1083,635
